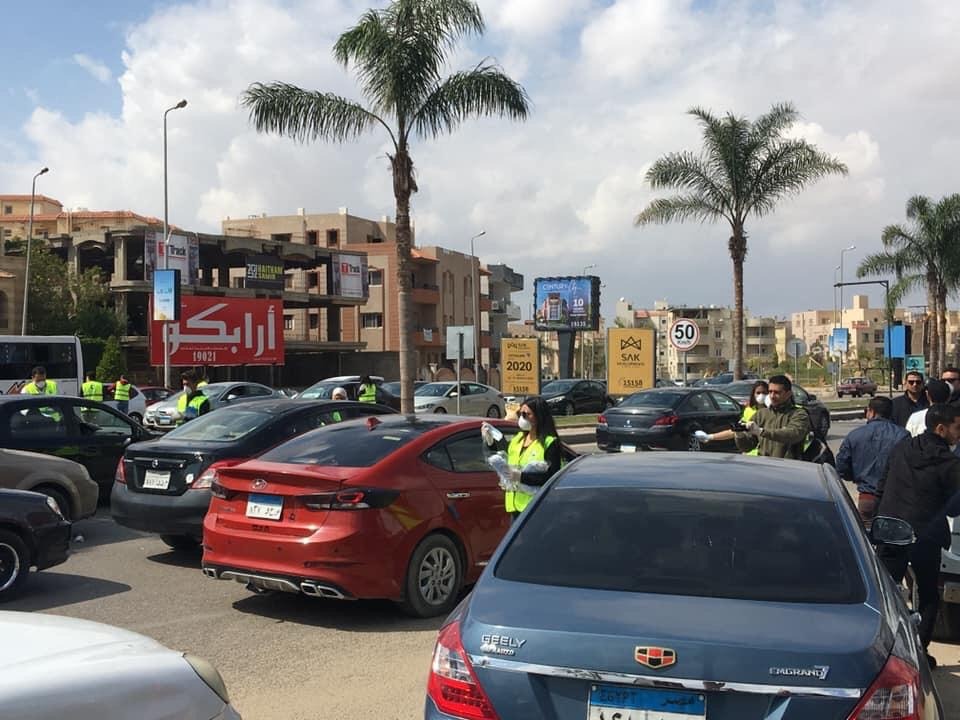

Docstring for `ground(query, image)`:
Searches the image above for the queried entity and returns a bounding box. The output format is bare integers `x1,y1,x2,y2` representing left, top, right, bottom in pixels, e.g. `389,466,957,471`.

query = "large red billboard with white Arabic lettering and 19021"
150,295,283,366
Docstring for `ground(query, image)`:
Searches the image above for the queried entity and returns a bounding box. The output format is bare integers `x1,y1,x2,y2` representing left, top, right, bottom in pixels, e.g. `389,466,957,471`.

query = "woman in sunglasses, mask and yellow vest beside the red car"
480,396,563,522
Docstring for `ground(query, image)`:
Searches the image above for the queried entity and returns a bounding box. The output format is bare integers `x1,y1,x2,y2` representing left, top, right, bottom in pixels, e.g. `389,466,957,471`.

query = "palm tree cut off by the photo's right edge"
857,194,960,377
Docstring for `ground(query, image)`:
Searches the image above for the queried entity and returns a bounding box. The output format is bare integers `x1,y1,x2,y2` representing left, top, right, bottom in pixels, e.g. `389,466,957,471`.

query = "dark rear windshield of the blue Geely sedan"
496,487,866,603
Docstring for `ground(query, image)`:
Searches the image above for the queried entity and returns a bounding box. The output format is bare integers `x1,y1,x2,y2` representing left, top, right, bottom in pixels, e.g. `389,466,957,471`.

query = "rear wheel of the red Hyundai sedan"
401,533,463,618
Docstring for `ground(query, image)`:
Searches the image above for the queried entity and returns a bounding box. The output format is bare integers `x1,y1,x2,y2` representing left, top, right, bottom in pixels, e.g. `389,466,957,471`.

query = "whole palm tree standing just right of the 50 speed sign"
634,103,847,378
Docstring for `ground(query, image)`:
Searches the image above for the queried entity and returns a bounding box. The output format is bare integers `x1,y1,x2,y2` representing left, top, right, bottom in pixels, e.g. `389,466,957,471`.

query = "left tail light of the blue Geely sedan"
427,622,497,720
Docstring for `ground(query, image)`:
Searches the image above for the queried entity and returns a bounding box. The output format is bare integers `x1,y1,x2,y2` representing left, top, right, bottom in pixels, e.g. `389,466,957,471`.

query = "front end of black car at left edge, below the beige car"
0,490,70,602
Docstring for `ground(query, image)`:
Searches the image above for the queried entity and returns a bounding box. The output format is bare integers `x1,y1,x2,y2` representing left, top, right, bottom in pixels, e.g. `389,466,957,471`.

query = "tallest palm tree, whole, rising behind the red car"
242,0,530,413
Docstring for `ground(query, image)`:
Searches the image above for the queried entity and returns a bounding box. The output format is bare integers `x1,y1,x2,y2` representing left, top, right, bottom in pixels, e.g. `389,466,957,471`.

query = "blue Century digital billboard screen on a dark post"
533,275,600,330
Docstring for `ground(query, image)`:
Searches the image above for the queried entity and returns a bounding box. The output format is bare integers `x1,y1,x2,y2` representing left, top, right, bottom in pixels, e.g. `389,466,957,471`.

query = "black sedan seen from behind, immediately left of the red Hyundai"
110,399,393,549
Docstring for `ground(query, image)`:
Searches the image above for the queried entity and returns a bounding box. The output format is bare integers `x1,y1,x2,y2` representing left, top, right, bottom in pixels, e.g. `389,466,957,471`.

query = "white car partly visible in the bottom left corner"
0,612,240,720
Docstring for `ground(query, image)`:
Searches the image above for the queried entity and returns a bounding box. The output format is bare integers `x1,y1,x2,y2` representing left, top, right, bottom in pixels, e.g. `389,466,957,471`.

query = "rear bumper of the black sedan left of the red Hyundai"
110,483,210,539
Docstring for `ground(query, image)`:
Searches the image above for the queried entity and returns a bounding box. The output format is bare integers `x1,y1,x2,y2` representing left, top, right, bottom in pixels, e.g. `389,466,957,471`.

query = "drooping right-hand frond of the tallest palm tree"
412,63,530,137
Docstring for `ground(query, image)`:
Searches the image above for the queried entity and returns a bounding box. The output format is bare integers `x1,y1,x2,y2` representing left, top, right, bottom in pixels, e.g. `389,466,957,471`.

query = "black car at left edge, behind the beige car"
0,395,155,497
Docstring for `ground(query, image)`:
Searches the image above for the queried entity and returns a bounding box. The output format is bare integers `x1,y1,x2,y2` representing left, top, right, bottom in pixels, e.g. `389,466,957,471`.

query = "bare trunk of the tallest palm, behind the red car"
390,145,417,415
